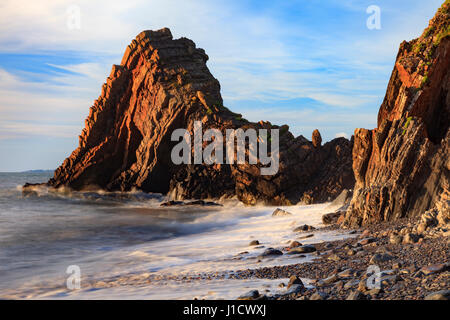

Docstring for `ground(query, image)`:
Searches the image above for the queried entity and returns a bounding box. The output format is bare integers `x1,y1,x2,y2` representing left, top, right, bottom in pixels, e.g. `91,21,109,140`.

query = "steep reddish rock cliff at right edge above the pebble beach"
344,1,450,226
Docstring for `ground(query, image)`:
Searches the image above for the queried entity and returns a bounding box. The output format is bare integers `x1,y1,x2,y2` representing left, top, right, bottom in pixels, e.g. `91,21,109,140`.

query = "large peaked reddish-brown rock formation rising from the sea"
35,29,354,205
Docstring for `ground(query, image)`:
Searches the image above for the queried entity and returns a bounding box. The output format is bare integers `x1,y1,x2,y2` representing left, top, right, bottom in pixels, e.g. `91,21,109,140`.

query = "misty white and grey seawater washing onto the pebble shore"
0,172,348,299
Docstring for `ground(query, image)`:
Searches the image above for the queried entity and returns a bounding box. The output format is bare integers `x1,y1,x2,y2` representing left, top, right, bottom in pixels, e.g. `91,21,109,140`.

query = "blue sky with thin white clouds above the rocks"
0,0,443,172
